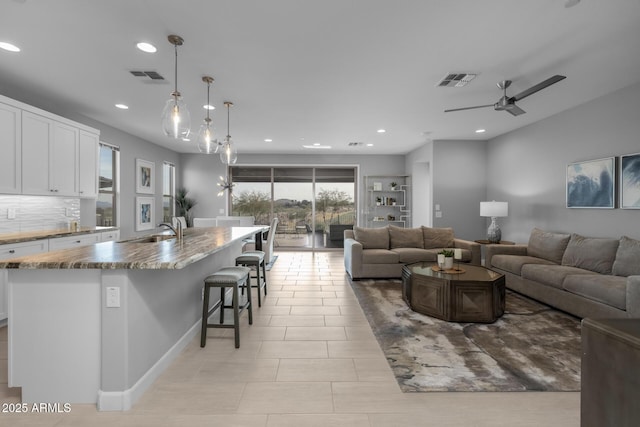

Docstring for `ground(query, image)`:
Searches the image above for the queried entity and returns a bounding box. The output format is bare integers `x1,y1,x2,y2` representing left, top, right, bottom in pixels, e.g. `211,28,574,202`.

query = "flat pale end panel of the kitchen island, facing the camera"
8,270,100,403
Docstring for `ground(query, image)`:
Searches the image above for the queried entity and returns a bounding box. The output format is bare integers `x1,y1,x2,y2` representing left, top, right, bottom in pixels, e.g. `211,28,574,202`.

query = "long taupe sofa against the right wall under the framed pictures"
485,228,640,318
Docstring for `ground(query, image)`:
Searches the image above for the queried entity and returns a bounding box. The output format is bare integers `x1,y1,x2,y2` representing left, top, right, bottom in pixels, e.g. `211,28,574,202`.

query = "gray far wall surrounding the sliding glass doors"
181,152,405,224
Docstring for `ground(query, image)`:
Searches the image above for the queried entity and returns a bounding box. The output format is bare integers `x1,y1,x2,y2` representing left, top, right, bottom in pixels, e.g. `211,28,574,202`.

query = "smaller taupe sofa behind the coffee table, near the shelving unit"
344,225,481,279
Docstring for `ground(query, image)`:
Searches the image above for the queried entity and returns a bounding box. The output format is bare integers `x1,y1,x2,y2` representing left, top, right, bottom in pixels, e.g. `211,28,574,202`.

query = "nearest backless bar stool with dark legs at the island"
200,267,253,348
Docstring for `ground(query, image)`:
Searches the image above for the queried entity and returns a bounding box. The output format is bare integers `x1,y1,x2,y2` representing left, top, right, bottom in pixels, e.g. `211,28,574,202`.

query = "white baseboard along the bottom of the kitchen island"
97,320,202,411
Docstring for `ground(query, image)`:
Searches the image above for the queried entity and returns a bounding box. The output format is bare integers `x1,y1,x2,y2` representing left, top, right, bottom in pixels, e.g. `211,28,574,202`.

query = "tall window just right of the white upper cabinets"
96,142,120,227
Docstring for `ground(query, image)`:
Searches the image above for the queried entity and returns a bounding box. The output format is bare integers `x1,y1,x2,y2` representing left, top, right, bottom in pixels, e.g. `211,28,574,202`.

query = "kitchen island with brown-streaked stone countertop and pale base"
0,226,268,410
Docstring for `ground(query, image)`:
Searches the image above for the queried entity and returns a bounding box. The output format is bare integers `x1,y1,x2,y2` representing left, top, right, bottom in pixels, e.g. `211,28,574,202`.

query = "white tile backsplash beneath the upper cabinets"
0,194,80,234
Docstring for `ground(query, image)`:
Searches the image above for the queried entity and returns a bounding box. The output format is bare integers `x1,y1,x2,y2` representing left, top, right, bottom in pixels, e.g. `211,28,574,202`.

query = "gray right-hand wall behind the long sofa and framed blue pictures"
487,84,640,242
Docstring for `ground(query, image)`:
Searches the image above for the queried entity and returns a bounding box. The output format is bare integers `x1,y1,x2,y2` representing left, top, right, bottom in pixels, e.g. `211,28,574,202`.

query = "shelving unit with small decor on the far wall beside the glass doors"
363,175,411,227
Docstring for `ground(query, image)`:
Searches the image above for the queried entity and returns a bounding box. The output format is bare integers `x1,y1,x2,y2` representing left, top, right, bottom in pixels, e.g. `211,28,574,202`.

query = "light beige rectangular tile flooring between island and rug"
0,252,580,427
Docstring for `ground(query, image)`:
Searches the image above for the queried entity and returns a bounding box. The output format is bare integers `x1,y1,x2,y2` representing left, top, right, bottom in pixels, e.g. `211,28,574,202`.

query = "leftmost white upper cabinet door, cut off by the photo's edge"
0,103,22,194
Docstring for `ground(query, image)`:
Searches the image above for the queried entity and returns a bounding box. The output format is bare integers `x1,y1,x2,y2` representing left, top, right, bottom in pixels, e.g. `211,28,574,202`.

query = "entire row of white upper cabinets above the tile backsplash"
0,97,99,198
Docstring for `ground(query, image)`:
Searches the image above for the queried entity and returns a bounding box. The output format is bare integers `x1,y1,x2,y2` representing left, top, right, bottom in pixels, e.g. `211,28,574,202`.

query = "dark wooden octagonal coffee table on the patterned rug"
402,262,505,323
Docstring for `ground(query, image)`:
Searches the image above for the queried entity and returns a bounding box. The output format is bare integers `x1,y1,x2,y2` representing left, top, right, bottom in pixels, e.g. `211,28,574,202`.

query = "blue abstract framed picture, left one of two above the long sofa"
567,157,616,209
